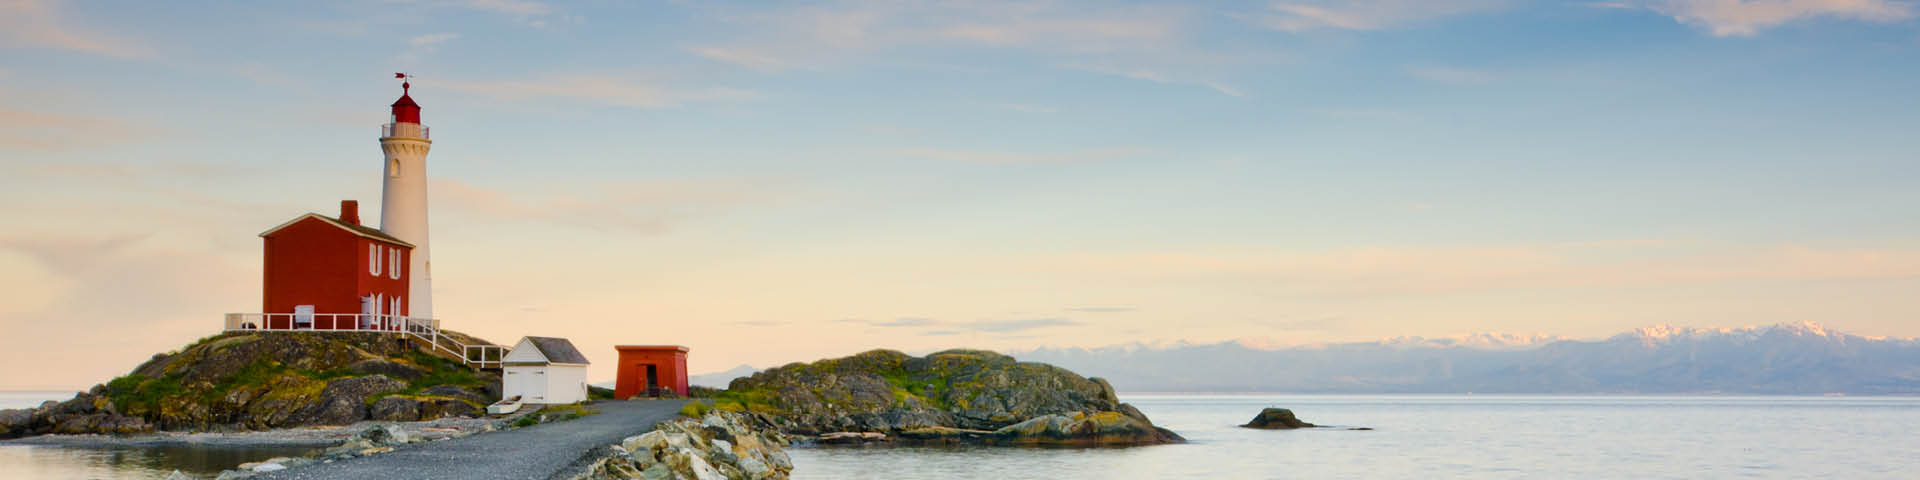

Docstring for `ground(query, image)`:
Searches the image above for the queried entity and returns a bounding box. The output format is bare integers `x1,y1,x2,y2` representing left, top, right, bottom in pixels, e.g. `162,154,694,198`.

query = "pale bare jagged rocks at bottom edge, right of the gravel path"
580,411,793,480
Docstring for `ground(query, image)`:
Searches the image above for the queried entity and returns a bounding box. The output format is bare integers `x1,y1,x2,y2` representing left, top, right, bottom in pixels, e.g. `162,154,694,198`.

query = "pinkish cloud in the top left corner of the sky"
0,0,157,60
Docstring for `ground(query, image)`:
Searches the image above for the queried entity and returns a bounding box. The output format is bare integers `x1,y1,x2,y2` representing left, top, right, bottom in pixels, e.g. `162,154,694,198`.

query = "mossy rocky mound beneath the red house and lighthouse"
0,332,499,438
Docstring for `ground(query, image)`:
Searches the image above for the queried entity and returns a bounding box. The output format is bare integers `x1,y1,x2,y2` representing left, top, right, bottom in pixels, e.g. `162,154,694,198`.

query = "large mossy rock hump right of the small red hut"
714,349,1181,445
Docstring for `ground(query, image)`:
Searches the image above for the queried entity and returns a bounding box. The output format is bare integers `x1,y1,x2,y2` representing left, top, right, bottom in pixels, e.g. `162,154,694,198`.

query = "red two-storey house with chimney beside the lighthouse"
253,200,413,330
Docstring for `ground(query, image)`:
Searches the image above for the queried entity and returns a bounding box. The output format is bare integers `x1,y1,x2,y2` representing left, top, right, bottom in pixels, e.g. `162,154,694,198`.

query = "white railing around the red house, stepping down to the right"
227,313,507,369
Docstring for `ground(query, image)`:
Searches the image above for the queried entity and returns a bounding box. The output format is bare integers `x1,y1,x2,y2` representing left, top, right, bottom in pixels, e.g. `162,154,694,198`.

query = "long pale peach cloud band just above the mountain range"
1018,242,1920,296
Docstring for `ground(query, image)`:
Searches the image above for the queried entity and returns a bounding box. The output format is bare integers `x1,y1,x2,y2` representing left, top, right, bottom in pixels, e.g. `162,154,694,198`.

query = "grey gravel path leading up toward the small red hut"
253,399,685,480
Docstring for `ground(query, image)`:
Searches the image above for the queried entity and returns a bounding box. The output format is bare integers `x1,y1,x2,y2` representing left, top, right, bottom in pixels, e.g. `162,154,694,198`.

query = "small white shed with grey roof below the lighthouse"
499,336,588,403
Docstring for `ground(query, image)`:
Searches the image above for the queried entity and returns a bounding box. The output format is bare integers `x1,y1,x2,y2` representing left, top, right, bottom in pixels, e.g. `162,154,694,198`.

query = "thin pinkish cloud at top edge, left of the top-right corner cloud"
1235,0,1511,33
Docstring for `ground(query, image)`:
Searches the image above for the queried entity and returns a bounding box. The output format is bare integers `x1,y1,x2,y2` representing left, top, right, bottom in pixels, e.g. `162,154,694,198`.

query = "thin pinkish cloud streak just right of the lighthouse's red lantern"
444,73,758,108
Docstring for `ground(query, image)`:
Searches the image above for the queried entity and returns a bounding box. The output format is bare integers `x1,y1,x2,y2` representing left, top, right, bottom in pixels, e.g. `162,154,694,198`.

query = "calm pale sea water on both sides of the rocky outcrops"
0,394,1920,478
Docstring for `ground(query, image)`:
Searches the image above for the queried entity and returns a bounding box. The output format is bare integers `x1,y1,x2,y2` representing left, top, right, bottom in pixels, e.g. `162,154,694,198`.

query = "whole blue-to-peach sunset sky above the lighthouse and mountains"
0,0,1920,390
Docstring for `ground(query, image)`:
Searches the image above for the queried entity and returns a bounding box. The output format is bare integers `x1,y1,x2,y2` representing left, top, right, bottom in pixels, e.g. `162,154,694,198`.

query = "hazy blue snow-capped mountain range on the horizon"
1010,323,1920,396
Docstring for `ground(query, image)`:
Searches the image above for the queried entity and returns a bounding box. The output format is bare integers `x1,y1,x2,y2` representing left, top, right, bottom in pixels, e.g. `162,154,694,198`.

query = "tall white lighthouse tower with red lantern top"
380,75,434,319
